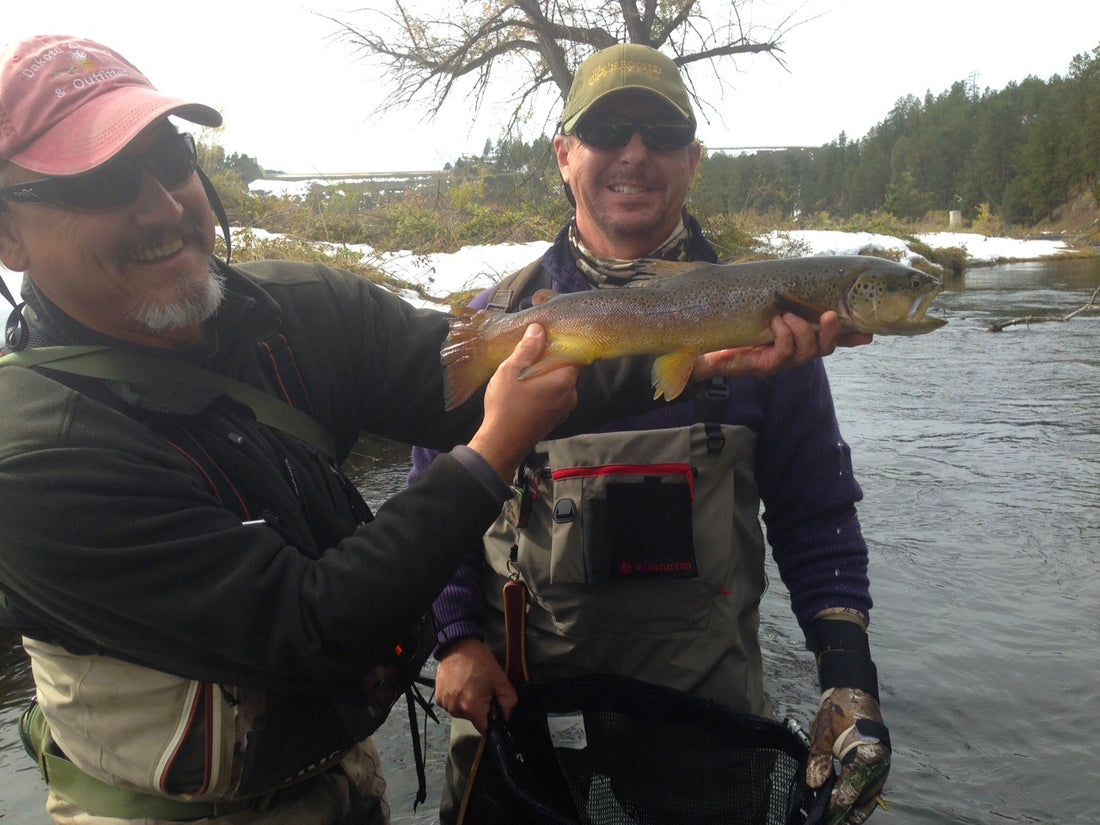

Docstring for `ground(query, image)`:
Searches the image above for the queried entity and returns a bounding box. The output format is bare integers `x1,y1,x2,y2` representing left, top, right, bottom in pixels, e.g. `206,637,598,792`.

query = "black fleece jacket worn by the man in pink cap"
0,262,653,693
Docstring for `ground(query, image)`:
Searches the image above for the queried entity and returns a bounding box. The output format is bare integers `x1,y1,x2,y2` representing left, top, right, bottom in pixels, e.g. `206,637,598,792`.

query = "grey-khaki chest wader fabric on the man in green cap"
440,424,772,825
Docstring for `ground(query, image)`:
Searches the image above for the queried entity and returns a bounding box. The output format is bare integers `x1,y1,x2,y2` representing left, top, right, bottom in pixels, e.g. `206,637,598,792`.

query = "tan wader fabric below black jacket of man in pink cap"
23,638,389,825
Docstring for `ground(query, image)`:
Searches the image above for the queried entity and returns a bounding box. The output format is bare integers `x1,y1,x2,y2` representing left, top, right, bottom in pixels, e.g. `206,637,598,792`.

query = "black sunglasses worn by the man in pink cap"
0,132,198,209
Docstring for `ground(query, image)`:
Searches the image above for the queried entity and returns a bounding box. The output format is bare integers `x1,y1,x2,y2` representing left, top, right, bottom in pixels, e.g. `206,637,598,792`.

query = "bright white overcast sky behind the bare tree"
8,0,1100,173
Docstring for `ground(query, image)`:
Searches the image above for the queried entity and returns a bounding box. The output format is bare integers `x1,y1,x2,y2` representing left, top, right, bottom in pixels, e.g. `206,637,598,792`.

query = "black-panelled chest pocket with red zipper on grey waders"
553,463,699,584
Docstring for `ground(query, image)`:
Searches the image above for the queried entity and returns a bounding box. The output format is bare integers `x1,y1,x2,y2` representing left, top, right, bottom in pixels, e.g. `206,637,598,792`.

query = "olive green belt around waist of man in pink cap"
19,702,253,822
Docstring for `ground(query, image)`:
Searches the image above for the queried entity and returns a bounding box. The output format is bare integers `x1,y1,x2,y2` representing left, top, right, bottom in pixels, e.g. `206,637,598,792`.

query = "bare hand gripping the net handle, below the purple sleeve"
436,639,519,734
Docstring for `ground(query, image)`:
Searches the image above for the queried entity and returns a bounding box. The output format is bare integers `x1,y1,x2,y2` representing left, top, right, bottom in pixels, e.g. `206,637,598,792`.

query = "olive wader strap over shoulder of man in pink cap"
0,347,336,459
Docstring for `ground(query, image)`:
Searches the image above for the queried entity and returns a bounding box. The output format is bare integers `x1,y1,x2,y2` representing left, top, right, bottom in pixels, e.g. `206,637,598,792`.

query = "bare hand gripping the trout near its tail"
468,325,580,481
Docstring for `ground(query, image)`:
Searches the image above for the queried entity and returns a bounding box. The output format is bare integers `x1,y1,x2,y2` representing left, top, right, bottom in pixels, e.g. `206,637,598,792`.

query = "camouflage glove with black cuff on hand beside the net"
806,616,890,825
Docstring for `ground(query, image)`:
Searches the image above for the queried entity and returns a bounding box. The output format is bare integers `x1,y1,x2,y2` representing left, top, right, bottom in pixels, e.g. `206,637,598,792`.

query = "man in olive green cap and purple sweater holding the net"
411,44,890,825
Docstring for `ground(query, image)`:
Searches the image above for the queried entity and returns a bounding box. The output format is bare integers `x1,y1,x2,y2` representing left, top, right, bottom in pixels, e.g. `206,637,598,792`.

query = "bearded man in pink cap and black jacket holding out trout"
0,36,839,825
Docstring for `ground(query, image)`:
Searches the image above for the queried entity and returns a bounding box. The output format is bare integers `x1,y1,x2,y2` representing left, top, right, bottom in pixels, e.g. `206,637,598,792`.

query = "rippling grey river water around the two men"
0,259,1100,825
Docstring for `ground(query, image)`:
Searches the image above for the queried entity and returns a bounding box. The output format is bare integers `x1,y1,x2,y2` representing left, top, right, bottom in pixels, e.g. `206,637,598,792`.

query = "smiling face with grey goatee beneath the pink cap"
0,120,221,347
